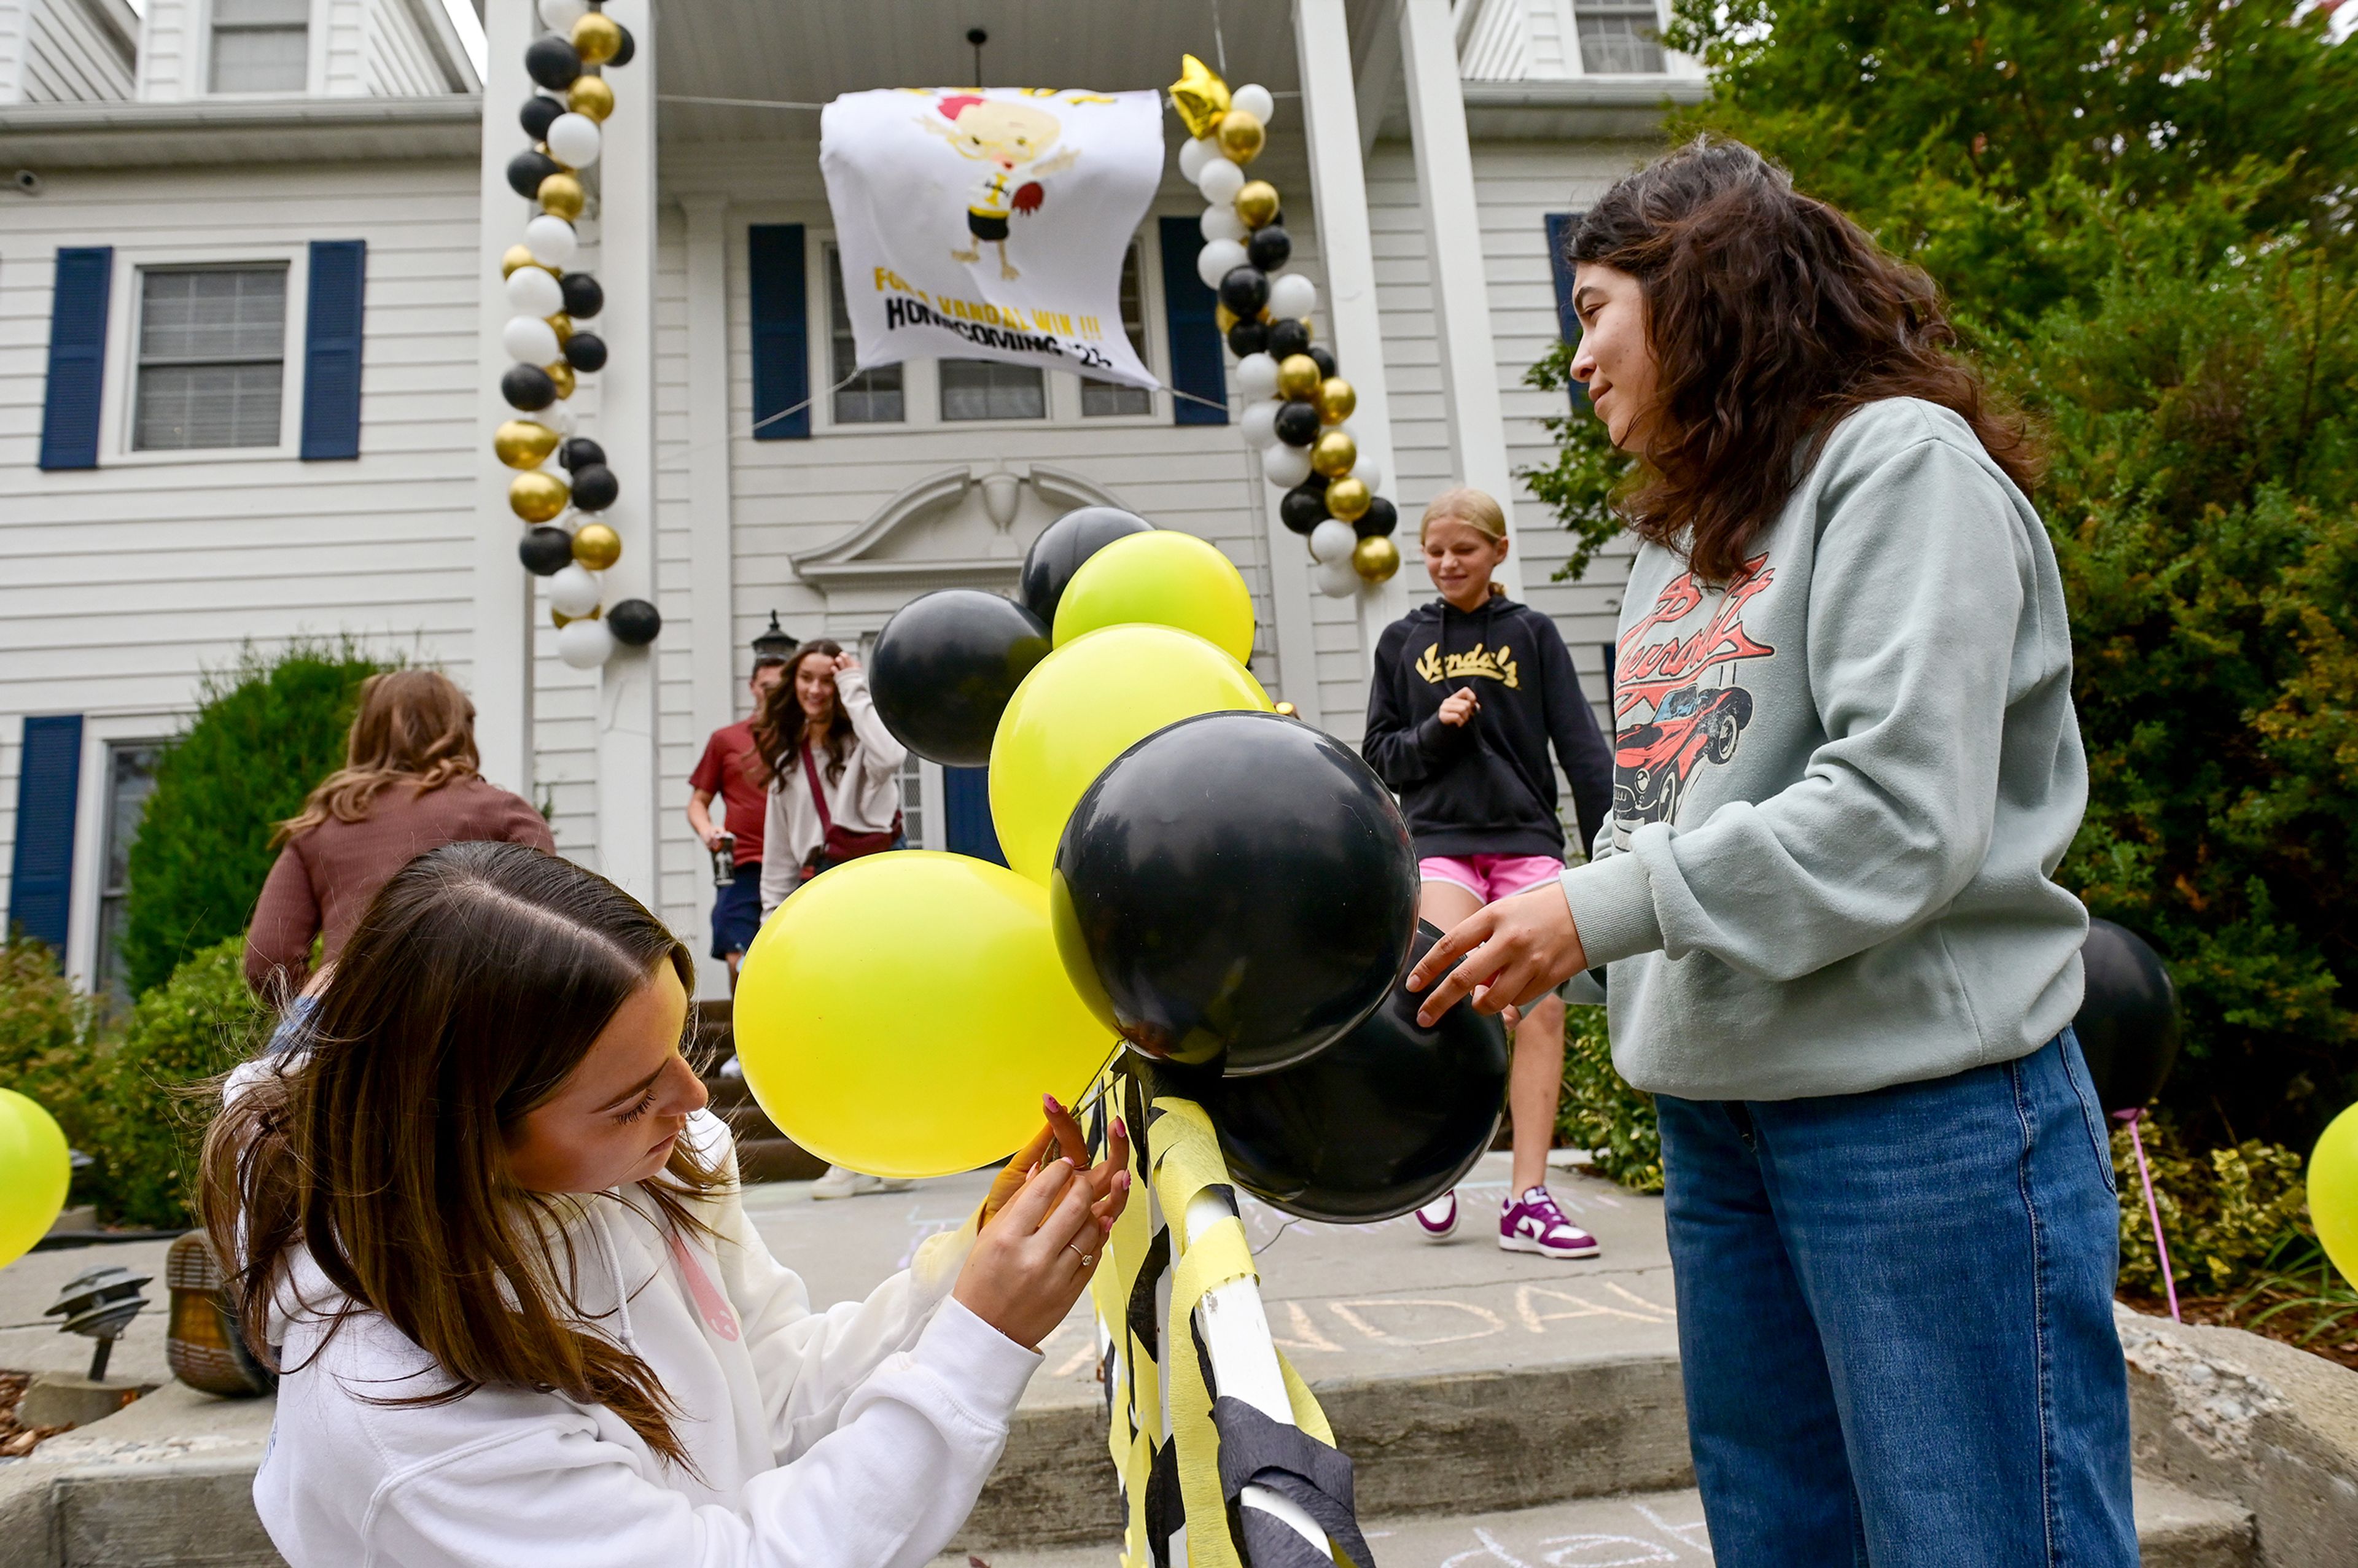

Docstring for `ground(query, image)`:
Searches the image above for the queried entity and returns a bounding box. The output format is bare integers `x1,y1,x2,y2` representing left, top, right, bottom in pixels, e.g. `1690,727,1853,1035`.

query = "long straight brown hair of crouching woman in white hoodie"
198,844,724,1464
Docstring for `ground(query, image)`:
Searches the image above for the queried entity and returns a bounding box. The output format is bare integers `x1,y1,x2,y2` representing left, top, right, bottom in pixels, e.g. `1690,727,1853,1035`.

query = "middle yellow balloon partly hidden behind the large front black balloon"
990,627,1271,896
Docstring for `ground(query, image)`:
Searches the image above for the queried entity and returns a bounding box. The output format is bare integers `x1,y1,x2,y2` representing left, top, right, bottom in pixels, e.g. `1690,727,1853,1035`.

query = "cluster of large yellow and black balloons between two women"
736,507,1507,1221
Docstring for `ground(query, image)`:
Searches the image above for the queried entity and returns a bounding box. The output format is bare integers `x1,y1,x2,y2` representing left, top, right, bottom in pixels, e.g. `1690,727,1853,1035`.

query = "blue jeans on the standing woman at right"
1656,1030,2136,1568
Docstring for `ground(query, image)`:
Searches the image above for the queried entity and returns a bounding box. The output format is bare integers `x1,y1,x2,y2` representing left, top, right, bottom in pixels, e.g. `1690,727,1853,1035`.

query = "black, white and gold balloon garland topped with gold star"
1170,54,1401,599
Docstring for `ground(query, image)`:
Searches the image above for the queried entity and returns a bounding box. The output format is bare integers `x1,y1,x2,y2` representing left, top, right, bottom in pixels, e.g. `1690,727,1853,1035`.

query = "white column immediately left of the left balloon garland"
467,0,538,799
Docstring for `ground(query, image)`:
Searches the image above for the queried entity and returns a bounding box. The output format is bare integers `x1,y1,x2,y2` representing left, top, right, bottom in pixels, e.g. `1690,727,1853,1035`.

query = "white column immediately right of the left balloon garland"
594,0,660,908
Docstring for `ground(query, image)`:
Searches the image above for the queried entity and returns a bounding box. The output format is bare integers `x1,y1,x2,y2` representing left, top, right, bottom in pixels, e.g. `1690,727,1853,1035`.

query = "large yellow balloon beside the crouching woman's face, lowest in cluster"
736,849,1118,1176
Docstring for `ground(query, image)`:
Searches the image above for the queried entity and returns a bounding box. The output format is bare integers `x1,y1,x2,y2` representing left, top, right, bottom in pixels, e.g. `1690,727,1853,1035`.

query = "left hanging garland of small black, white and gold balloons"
491,0,663,670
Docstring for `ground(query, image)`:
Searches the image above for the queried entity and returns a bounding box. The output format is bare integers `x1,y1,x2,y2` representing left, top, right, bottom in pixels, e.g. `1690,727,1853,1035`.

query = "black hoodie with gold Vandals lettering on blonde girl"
1361,594,1613,856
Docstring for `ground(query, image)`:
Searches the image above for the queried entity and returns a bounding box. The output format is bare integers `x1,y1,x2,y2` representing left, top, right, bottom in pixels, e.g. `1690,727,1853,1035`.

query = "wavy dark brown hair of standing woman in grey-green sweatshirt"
1570,137,2035,583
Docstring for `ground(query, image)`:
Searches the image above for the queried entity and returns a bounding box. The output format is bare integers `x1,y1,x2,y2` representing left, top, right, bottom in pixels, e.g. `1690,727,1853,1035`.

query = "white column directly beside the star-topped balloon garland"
1271,0,1407,662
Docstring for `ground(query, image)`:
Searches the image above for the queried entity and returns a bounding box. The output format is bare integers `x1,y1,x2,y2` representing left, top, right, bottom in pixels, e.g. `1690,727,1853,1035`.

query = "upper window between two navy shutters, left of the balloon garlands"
132,262,287,452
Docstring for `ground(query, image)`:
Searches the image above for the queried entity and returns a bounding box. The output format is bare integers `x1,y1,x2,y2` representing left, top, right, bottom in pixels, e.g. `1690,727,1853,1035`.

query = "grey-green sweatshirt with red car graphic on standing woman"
1563,398,2087,1099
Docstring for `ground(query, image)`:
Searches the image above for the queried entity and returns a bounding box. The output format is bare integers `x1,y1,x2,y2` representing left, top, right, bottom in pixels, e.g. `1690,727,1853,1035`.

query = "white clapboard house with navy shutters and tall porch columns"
0,0,1702,984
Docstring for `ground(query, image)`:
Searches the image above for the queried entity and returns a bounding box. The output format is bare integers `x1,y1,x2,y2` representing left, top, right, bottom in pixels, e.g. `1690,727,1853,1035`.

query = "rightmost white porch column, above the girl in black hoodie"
1401,0,1523,599
